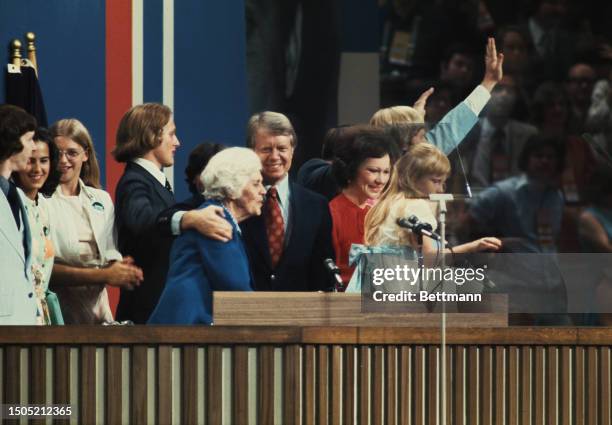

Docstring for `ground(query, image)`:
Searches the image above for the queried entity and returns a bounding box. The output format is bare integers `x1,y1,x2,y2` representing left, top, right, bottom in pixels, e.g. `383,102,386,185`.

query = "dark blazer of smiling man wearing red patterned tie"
240,182,334,291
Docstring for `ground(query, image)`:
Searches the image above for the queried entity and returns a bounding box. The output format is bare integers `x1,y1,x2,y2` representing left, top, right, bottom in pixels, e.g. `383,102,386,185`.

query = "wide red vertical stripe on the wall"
105,0,132,313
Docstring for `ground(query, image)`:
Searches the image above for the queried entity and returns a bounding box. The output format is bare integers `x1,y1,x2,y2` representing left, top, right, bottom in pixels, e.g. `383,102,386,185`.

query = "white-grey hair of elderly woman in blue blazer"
200,147,261,201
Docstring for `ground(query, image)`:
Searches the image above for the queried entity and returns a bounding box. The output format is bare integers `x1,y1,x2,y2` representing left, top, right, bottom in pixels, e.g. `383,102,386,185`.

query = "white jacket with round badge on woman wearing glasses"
46,180,122,266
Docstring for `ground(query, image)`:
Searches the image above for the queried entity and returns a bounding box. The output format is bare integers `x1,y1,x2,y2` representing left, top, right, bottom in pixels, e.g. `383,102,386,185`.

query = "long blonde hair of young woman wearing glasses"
50,118,101,189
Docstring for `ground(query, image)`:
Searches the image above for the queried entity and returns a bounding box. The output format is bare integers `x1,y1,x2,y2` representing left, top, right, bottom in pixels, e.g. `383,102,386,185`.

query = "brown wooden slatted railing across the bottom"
0,326,612,425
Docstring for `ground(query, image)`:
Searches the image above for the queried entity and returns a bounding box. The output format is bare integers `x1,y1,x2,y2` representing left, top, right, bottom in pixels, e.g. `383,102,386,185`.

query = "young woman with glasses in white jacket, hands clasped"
48,119,142,324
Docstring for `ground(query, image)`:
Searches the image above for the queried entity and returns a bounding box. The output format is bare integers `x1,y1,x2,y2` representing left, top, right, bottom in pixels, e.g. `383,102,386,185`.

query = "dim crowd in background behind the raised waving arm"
380,0,612,322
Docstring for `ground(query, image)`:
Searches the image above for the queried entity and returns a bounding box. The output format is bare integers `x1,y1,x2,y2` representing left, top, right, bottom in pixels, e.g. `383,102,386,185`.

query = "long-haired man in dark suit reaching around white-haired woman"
113,103,228,323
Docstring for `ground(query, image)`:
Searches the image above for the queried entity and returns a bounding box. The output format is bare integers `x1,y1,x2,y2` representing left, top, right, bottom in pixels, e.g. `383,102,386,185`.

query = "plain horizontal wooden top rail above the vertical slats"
0,326,612,346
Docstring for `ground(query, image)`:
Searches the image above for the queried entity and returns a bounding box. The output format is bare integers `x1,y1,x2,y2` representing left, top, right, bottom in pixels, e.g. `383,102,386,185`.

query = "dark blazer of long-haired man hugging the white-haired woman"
115,162,175,323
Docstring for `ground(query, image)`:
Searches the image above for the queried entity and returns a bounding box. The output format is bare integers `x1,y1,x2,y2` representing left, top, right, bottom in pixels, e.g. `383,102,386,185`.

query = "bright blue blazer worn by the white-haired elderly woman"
148,201,252,325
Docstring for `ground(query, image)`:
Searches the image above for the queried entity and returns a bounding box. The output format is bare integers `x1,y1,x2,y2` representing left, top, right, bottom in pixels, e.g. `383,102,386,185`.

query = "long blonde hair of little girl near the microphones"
364,143,450,245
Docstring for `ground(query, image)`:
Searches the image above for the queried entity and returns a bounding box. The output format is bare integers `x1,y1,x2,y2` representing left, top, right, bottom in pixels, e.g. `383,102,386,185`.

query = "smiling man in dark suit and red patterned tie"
240,112,333,291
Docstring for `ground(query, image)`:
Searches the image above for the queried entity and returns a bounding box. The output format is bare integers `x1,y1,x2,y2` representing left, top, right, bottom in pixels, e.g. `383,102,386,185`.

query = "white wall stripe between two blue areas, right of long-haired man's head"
162,0,174,187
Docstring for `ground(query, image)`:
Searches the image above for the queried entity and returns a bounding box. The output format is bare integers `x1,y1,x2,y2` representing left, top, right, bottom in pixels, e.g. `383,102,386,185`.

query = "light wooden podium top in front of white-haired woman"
213,292,508,328
